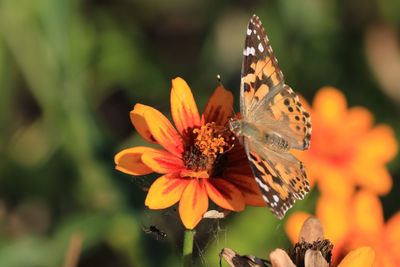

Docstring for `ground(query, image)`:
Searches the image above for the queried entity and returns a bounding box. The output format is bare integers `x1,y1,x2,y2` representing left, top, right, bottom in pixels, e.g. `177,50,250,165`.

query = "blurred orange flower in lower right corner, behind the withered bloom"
285,190,400,267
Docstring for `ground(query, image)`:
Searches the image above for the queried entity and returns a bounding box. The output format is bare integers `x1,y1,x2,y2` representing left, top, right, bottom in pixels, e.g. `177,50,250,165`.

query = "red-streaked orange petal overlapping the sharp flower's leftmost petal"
142,150,184,173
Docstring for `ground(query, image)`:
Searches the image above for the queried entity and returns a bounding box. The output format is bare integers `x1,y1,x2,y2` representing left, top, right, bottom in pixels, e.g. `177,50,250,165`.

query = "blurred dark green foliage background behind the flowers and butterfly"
0,0,400,267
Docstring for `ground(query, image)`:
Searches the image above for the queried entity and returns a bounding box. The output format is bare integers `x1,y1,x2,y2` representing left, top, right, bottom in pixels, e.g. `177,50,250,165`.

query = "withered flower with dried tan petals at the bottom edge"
220,217,375,267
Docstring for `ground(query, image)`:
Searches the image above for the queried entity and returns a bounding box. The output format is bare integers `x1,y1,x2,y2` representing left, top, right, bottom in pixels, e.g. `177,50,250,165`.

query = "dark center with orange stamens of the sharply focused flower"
181,122,234,178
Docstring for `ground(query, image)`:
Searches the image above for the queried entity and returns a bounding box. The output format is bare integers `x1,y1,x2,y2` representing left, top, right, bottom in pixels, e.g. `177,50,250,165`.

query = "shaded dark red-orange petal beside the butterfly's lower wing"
225,173,266,207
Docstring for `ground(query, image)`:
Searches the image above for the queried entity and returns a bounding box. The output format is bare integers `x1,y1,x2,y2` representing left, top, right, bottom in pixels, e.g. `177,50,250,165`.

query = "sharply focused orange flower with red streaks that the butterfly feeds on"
115,78,265,229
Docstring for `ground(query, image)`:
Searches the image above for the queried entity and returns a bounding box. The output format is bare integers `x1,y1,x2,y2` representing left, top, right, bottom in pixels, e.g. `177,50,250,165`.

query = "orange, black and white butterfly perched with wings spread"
229,15,312,219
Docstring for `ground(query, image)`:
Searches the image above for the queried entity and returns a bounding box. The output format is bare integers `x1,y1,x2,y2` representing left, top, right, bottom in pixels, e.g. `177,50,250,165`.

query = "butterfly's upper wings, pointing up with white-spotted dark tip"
240,15,312,150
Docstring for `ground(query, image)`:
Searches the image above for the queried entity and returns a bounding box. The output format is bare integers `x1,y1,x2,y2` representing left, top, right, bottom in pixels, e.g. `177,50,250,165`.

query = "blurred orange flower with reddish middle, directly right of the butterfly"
298,87,397,197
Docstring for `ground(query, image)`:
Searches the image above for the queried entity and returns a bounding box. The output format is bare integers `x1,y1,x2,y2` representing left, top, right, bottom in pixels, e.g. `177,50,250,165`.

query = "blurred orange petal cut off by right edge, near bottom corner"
383,212,400,263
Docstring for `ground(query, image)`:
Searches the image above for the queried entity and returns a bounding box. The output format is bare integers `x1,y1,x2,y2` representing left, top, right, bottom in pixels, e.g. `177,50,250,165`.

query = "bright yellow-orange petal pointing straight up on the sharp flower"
171,77,201,134
